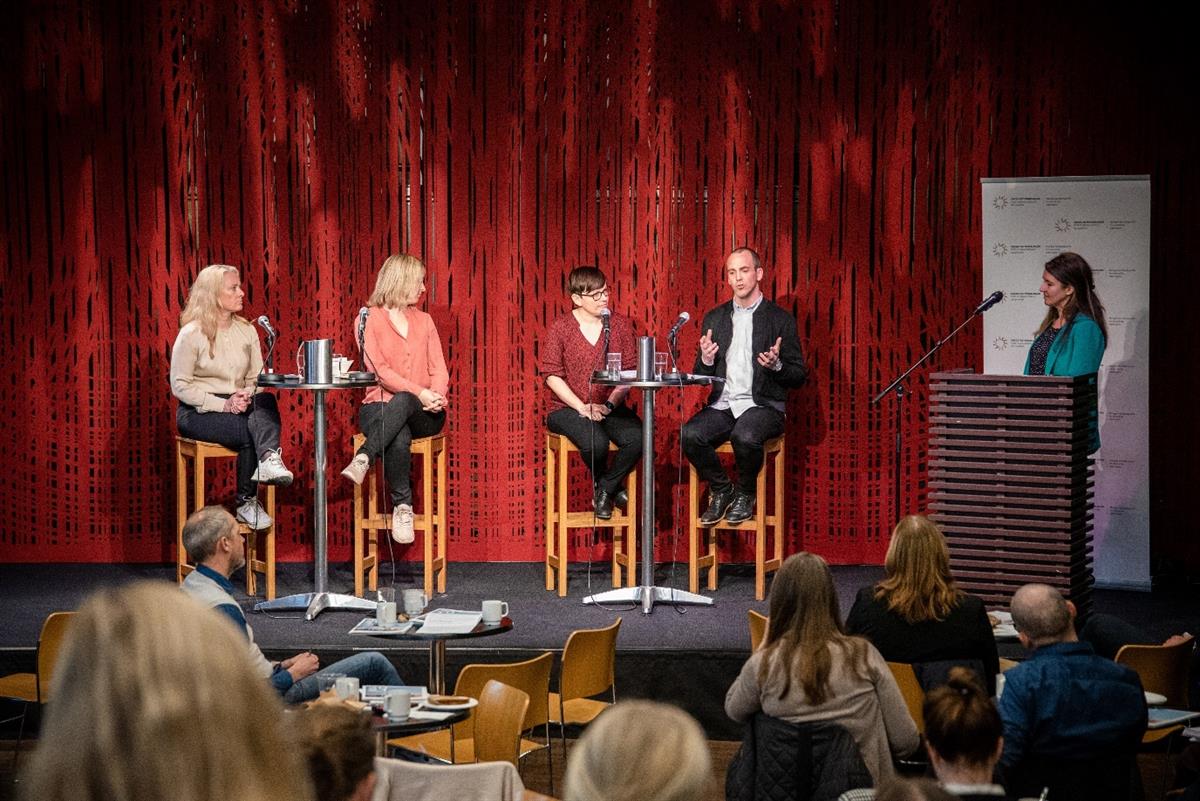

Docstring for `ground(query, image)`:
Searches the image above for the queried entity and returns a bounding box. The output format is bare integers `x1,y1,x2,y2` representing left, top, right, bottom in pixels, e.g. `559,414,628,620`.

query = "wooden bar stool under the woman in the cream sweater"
175,435,275,601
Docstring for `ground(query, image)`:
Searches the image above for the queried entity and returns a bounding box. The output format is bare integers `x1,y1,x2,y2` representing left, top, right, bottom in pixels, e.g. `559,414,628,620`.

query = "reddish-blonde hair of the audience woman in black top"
875,514,962,624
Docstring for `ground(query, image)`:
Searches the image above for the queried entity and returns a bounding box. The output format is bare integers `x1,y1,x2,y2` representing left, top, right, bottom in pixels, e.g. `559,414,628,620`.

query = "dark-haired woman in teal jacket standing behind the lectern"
1025,252,1109,453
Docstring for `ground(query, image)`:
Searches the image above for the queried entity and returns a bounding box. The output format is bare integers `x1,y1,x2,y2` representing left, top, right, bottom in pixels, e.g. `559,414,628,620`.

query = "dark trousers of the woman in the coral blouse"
359,392,446,506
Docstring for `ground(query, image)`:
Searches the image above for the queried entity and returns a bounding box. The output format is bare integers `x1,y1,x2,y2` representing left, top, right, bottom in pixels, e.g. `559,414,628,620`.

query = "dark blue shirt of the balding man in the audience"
1000,643,1146,767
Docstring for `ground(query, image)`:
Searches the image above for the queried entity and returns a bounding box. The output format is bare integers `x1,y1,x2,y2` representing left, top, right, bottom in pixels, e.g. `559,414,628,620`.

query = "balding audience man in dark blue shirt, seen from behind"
1000,584,1146,799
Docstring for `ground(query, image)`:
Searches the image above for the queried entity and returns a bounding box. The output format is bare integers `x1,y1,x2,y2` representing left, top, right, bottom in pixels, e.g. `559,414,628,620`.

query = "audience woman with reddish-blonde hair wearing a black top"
846,514,1000,692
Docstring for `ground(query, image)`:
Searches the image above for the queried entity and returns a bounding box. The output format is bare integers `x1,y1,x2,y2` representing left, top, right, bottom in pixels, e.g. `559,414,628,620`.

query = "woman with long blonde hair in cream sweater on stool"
170,264,292,529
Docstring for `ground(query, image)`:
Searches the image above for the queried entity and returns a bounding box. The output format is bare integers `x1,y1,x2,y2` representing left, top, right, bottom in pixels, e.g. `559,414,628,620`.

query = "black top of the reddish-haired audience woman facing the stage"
846,586,1000,692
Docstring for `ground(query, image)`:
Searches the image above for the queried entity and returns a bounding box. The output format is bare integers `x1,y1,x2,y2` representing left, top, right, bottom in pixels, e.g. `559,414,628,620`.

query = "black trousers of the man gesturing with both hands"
680,406,784,496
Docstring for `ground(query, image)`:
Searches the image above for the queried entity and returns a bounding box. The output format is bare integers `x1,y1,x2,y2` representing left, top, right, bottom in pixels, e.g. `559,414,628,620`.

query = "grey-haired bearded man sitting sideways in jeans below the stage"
184,506,404,704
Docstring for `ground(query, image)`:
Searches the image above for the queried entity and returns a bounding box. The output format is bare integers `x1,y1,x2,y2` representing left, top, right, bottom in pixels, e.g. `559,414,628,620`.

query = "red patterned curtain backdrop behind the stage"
0,0,1198,573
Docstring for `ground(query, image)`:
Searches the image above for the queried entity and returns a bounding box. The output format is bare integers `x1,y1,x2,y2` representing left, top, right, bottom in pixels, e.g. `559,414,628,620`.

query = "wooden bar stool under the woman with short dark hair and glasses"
546,433,637,597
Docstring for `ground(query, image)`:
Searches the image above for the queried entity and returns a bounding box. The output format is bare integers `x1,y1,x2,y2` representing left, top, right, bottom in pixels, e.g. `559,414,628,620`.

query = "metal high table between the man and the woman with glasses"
583,373,724,615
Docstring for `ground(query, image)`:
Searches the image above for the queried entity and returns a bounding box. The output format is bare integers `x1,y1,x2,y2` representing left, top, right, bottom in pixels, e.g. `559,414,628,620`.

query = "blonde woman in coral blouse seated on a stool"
342,253,450,543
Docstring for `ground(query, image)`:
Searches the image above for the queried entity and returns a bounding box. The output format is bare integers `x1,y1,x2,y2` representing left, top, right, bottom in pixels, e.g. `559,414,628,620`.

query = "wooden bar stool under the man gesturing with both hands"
688,435,787,601
